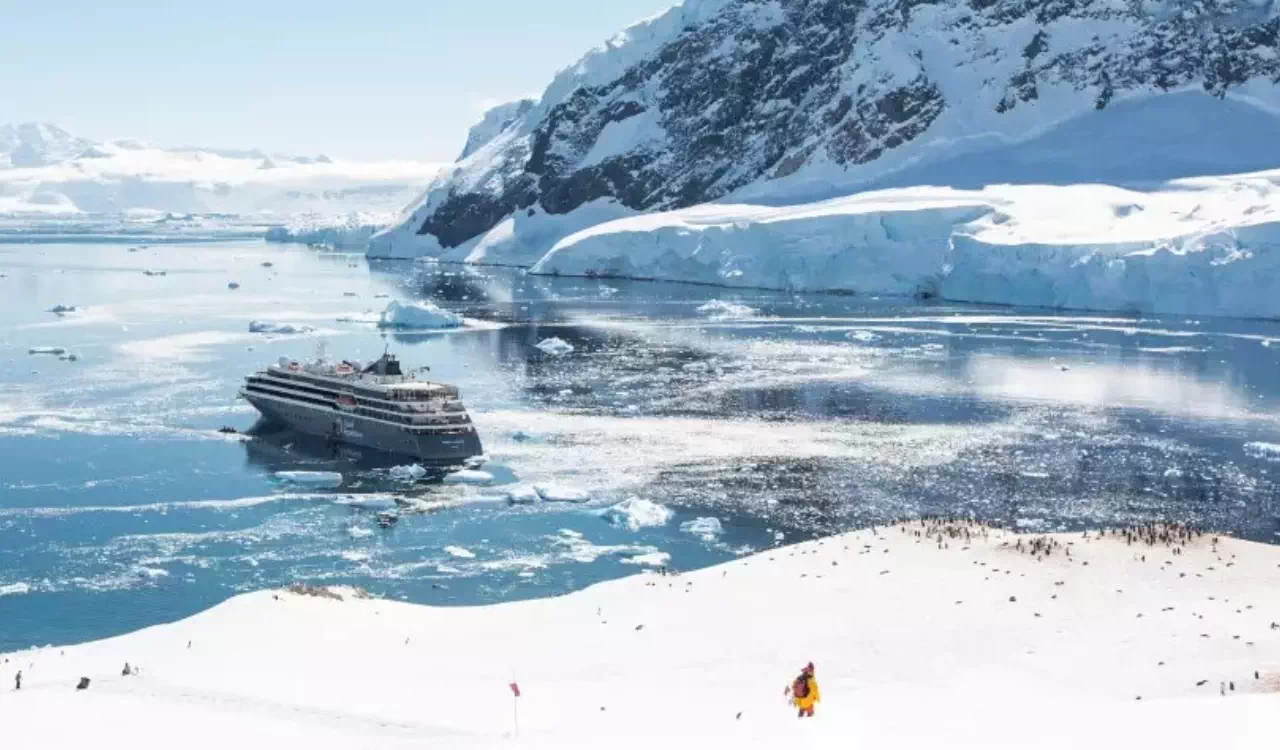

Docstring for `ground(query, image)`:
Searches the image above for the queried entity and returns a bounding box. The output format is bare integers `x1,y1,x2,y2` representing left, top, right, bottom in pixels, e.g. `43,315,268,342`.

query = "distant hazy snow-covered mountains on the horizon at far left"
0,123,439,218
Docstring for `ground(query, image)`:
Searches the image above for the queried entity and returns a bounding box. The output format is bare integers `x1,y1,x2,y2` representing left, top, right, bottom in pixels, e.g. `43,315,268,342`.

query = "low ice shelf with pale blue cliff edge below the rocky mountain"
532,170,1280,317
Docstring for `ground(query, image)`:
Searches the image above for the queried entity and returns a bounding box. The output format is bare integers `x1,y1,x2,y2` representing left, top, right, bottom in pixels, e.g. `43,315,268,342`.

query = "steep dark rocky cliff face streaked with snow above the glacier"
371,0,1280,260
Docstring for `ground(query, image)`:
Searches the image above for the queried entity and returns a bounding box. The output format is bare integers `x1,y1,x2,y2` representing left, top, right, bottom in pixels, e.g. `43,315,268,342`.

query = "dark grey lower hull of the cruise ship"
243,393,484,466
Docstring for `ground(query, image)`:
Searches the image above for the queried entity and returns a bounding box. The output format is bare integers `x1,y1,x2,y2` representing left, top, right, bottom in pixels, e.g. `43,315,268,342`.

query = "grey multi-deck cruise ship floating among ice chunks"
241,353,483,466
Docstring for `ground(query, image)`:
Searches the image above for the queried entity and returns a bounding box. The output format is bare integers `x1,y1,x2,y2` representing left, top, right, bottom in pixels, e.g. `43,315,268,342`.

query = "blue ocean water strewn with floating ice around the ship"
0,242,1280,651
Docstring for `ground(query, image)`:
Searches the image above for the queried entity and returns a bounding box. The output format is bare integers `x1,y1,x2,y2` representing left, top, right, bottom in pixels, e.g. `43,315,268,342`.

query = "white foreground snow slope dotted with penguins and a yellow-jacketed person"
0,525,1280,750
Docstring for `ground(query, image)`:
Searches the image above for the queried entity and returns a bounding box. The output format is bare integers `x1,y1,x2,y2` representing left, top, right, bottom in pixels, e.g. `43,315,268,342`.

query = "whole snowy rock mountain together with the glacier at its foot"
367,0,1280,317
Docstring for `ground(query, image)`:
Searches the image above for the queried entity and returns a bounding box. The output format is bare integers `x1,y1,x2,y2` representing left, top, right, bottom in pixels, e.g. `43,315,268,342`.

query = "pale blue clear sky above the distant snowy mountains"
0,0,676,161
